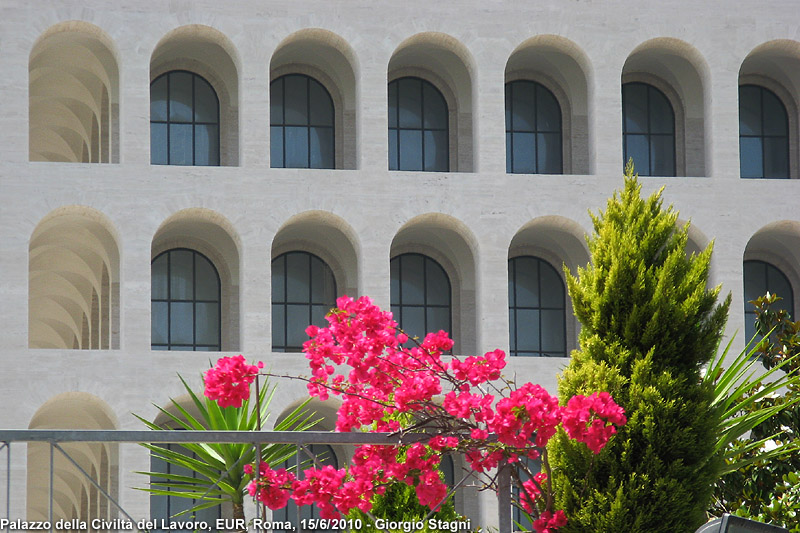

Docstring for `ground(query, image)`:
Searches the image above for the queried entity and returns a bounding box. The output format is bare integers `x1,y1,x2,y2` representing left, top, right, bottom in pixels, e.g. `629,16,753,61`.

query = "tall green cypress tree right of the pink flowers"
548,164,730,533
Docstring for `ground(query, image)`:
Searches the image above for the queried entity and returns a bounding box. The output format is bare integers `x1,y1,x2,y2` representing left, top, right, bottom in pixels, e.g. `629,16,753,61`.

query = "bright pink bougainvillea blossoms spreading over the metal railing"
206,296,626,533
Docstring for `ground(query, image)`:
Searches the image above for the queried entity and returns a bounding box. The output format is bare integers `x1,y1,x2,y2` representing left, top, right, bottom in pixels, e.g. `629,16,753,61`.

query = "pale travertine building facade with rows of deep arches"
0,0,800,525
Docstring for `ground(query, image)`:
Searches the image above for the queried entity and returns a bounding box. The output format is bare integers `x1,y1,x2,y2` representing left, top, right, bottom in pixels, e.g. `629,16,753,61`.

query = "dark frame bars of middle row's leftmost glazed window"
150,247,222,352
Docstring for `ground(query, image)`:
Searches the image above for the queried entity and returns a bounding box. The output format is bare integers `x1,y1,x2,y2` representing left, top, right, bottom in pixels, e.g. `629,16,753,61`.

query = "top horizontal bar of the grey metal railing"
0,429,433,445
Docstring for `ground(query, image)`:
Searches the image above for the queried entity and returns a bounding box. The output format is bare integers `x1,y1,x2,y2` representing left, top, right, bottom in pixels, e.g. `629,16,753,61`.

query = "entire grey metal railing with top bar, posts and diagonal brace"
0,429,512,533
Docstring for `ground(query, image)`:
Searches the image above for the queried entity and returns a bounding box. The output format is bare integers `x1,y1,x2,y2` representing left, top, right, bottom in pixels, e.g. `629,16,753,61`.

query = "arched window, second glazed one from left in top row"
269,74,334,168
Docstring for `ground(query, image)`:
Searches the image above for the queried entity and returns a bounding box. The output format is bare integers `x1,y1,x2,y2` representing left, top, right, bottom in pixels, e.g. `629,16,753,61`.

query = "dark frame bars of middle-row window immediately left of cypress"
508,255,569,357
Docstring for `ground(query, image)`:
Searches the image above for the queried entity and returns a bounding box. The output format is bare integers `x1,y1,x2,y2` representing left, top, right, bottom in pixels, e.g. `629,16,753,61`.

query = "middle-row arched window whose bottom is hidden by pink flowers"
390,253,453,340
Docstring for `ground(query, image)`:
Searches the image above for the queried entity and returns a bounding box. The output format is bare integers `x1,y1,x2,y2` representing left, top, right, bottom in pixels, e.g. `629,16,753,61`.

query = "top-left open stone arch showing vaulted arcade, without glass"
28,20,119,163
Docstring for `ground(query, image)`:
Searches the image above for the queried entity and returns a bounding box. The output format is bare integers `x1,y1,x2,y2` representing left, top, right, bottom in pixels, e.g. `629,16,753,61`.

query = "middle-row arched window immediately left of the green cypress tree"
508,257,567,357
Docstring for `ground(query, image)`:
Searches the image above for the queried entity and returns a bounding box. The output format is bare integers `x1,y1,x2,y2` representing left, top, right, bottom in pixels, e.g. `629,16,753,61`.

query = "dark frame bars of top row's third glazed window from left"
387,75,450,172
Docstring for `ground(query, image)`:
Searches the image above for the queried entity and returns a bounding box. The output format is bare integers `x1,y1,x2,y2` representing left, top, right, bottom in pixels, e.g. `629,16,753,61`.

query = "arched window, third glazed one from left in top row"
389,77,450,172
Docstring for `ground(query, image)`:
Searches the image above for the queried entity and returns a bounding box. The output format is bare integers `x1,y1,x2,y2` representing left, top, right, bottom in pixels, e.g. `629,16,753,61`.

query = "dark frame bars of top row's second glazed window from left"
269,72,337,170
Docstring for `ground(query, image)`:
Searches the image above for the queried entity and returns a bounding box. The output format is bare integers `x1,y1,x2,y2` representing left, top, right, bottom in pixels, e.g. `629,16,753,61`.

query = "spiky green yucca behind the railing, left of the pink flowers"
134,375,317,519
